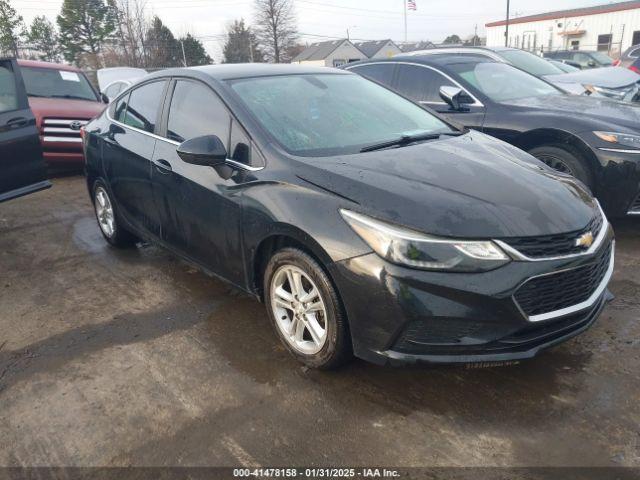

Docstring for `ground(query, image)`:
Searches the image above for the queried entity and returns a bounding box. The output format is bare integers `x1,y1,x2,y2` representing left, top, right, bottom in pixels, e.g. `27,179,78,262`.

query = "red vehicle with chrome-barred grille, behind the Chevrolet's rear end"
18,60,105,168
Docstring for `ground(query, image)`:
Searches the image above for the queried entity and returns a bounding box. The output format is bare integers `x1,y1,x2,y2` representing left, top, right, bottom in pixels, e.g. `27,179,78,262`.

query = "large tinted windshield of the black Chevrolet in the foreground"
230,73,452,157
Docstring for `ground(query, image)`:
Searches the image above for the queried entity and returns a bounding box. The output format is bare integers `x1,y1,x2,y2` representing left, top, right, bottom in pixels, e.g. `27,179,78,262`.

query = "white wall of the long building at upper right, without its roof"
486,8,640,56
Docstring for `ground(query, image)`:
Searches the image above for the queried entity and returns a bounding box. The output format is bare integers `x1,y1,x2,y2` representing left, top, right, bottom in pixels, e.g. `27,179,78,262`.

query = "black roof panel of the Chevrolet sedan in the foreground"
145,63,349,80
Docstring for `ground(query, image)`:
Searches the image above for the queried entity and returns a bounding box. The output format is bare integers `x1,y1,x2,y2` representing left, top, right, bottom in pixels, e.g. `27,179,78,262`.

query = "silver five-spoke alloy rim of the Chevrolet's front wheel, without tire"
270,265,327,355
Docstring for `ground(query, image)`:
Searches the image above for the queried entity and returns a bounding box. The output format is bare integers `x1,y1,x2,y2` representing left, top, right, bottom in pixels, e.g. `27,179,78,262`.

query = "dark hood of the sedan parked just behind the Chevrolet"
502,95,640,133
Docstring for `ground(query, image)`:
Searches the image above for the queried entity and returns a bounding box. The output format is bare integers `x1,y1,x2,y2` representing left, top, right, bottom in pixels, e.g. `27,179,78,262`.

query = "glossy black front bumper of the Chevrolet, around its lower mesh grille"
332,227,613,364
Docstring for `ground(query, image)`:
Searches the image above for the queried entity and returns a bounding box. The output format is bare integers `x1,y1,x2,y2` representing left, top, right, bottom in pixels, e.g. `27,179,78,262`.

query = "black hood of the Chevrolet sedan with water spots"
298,132,597,238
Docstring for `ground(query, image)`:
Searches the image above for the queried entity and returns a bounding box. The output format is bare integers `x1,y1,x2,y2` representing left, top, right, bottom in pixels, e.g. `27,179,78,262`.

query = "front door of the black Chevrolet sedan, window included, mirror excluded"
152,80,250,284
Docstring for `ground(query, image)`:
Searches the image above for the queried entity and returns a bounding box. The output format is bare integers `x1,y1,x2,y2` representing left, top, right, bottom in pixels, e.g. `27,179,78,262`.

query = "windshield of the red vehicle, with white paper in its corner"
20,67,98,101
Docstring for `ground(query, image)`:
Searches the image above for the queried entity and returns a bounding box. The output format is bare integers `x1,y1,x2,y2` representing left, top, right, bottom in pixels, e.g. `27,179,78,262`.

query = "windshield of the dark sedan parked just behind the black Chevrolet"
450,62,562,102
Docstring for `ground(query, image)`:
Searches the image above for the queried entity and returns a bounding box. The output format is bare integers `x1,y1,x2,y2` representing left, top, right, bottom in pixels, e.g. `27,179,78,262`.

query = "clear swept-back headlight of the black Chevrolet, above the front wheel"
340,210,511,272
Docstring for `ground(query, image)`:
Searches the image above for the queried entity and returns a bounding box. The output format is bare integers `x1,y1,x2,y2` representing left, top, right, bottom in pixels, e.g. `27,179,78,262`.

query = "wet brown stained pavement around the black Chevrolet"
0,177,640,466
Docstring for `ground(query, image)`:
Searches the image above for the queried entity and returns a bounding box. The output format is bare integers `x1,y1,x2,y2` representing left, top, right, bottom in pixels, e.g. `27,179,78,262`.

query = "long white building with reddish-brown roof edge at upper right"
486,1,640,56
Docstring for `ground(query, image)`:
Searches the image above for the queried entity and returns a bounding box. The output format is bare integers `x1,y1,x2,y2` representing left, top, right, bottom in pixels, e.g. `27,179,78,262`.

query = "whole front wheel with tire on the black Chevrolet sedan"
263,248,353,370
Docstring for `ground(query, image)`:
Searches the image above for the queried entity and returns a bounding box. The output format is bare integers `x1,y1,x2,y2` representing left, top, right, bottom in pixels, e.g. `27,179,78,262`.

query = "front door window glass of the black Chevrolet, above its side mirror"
167,80,231,145
